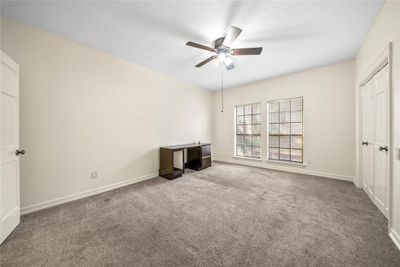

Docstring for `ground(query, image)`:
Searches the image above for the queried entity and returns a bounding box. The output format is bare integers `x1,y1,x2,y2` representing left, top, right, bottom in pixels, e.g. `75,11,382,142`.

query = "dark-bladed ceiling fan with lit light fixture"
186,25,262,70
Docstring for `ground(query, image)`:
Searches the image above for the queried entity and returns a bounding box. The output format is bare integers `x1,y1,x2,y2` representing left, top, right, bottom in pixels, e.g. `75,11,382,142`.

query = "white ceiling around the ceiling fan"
1,0,383,89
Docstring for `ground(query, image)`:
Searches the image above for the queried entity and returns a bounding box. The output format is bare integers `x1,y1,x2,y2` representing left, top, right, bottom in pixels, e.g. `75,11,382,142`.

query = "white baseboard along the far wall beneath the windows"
214,158,355,183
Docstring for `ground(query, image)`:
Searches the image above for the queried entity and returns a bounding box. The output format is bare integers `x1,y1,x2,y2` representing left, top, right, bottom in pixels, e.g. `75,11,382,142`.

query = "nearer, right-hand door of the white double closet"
374,65,389,217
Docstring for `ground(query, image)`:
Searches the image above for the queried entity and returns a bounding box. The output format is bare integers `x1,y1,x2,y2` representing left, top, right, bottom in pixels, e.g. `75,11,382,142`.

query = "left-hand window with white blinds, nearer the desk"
235,103,261,159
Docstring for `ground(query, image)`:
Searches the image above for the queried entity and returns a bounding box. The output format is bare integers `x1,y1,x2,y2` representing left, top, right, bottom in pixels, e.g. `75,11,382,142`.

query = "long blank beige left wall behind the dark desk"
1,18,213,211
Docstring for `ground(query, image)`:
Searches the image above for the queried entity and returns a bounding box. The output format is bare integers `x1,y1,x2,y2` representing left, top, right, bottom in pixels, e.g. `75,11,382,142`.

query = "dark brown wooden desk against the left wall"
158,144,211,180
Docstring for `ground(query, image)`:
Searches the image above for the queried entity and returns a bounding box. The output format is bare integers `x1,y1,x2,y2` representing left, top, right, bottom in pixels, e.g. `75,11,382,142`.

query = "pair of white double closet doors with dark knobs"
361,65,389,220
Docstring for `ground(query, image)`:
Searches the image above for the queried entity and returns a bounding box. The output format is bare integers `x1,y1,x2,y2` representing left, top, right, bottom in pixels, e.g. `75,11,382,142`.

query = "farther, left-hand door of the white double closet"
362,81,375,199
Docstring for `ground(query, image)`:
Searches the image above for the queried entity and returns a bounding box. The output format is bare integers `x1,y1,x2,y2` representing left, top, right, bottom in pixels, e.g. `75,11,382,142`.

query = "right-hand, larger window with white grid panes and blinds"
268,97,303,163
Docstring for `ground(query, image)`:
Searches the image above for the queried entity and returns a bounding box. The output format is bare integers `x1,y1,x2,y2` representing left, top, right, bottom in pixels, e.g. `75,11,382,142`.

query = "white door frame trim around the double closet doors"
356,42,394,228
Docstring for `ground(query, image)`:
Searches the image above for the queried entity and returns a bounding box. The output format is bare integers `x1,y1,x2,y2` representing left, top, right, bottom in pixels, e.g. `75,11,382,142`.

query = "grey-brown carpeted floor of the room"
0,163,400,266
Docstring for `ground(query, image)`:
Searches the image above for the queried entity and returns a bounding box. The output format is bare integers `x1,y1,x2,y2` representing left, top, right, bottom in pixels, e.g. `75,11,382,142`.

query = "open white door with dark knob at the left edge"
0,52,21,244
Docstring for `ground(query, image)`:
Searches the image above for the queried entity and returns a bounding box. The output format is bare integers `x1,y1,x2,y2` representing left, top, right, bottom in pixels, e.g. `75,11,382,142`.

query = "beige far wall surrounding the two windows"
214,61,355,180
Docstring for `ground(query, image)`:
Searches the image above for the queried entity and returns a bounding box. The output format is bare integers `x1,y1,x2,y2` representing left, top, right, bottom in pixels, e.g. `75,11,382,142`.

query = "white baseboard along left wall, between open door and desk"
21,172,158,215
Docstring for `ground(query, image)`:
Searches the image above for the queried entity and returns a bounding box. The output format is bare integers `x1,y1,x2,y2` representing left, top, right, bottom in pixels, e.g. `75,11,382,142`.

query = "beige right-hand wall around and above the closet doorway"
356,1,400,246
